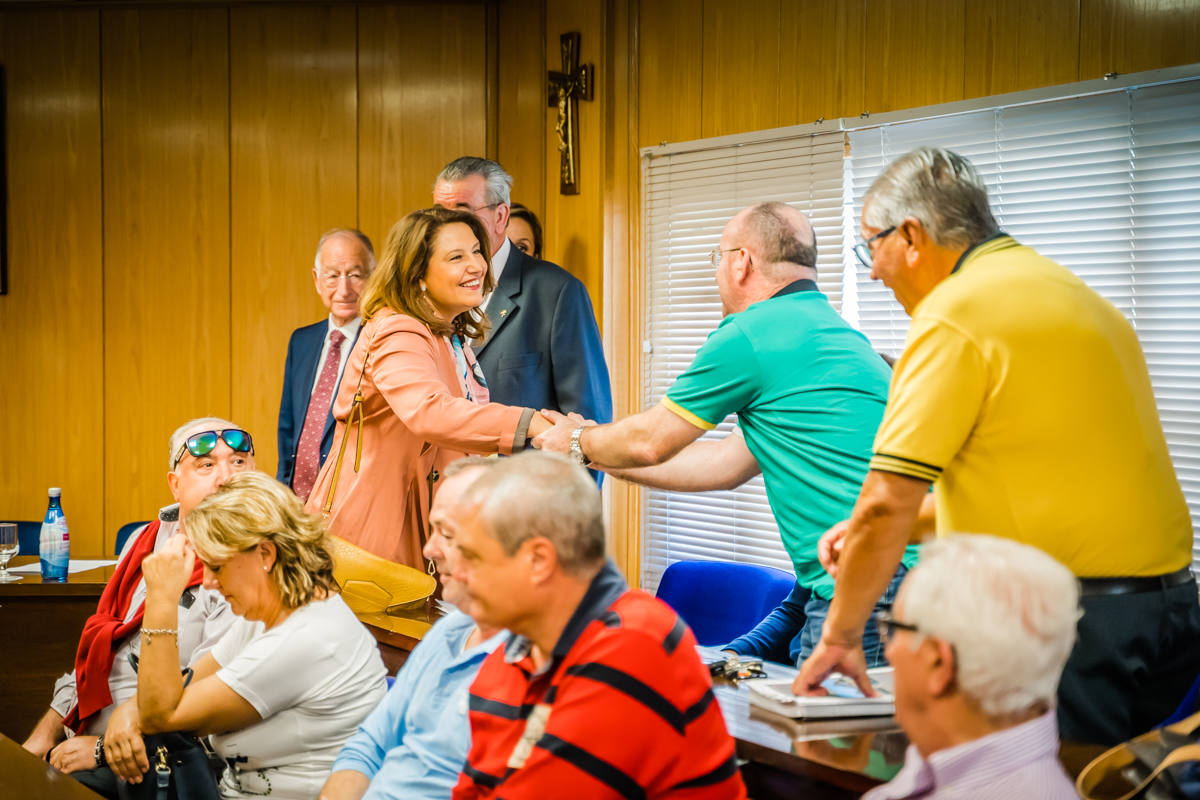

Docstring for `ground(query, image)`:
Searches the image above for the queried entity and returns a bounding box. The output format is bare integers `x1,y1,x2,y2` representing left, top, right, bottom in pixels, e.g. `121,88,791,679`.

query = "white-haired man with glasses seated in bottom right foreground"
864,535,1079,800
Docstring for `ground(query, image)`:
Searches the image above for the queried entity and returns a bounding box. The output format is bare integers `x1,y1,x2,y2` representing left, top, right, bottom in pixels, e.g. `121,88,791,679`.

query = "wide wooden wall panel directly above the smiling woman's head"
359,4,488,249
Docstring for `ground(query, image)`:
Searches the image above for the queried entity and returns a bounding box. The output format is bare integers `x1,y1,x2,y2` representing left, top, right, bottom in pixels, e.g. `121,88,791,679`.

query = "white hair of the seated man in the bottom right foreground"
901,534,1080,716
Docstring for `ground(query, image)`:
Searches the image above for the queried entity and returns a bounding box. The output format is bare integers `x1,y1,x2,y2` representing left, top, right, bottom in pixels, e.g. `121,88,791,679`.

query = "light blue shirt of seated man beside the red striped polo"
332,610,508,800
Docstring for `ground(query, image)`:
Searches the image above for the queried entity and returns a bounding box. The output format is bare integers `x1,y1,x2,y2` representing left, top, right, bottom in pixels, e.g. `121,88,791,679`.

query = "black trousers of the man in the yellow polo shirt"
1058,581,1200,746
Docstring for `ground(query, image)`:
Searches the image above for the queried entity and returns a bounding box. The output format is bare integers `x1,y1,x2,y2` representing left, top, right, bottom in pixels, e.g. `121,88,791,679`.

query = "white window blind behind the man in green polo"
642,131,844,591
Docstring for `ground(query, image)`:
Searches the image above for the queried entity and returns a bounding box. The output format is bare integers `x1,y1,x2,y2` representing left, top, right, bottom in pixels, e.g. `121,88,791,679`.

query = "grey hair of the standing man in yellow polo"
863,148,1000,248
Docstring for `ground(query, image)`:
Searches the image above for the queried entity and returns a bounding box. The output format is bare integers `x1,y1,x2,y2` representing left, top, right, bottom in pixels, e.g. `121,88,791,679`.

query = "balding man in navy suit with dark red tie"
275,228,374,495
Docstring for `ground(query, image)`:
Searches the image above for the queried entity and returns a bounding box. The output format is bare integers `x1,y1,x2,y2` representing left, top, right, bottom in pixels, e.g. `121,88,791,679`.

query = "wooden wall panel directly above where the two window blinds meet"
779,0,866,125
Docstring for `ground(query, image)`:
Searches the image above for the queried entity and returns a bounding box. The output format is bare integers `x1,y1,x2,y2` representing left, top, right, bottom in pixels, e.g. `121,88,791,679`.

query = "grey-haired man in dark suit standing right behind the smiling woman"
433,156,612,422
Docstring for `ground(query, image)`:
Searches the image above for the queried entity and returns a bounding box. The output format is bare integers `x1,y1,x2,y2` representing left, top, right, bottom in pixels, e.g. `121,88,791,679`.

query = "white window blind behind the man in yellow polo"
846,79,1200,569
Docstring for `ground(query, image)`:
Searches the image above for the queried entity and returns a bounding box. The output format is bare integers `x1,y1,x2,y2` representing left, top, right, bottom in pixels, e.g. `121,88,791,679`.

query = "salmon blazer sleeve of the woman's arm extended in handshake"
370,314,533,455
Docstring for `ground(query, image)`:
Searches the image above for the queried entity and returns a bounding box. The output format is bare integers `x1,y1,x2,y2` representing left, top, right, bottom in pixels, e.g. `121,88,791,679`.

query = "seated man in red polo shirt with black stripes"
451,452,746,800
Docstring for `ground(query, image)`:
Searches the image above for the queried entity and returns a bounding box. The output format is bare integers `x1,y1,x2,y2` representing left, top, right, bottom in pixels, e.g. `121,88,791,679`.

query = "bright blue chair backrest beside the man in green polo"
656,561,796,646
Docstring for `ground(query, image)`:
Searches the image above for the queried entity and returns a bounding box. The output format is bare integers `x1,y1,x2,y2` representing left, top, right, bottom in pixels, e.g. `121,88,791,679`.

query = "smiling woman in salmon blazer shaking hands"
307,209,550,570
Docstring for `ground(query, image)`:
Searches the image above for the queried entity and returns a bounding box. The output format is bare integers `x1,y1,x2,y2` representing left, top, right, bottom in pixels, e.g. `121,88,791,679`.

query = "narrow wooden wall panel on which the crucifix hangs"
542,0,606,309
